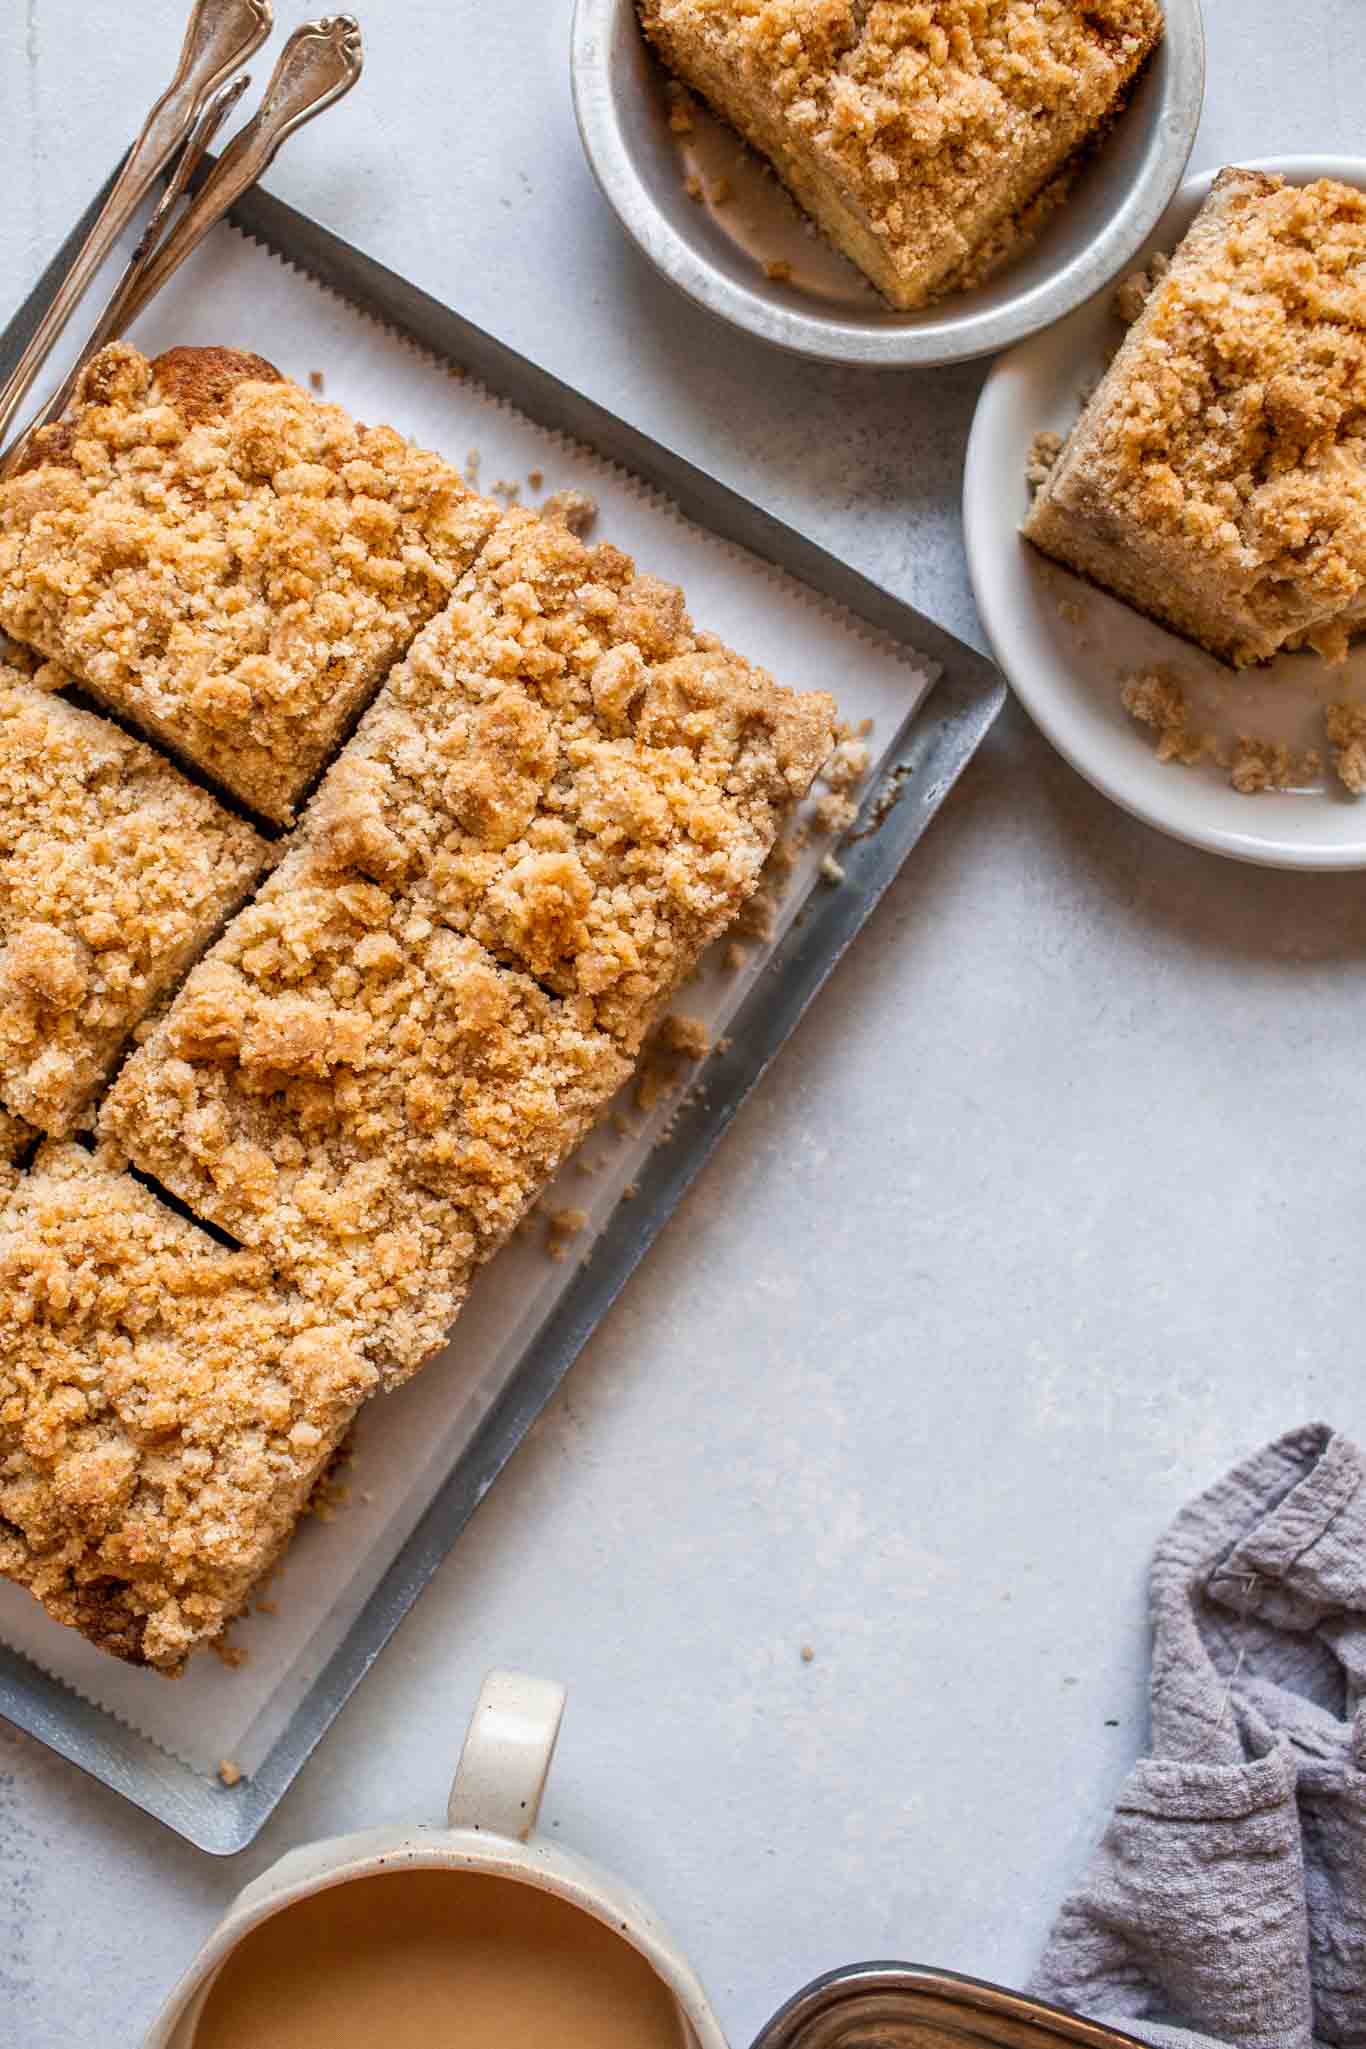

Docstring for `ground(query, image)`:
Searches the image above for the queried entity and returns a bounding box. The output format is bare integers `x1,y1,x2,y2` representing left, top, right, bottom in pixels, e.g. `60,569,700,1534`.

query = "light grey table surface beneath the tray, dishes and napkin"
0,0,1366,2049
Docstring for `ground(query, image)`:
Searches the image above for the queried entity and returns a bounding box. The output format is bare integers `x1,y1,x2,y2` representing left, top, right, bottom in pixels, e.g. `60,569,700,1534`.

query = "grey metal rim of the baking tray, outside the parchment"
0,172,1006,1856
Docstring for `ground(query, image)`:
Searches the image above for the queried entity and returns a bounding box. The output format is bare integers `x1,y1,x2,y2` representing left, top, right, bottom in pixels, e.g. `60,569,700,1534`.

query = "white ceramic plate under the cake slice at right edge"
963,156,1366,869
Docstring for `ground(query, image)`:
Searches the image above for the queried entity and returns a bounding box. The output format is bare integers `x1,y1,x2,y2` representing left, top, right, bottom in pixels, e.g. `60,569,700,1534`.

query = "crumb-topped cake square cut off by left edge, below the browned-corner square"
0,664,268,1137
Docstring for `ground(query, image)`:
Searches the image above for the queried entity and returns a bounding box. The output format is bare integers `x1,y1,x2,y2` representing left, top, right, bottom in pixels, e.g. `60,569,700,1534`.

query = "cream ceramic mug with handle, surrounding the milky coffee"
145,1672,727,2049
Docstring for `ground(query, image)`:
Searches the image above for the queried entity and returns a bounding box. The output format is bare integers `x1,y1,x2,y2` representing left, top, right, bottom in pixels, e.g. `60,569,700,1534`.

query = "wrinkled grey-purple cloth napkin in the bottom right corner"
1030,1424,1366,2049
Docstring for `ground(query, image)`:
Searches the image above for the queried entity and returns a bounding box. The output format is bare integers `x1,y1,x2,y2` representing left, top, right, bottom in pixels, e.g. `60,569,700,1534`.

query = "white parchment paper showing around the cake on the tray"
0,229,934,1799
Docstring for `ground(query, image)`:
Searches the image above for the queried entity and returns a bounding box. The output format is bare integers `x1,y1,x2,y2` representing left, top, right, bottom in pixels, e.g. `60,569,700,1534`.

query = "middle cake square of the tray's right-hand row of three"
100,848,631,1379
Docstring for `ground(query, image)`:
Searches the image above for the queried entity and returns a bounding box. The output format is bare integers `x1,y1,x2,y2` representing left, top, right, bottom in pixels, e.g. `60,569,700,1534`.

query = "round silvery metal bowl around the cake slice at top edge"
571,0,1204,369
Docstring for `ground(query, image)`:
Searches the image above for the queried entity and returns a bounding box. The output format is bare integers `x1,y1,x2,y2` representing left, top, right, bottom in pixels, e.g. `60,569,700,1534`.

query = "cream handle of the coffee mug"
446,1672,565,1842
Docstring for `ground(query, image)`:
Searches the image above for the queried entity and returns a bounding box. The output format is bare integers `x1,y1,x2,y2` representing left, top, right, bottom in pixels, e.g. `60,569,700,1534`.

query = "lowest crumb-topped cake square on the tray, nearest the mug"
0,1143,375,1670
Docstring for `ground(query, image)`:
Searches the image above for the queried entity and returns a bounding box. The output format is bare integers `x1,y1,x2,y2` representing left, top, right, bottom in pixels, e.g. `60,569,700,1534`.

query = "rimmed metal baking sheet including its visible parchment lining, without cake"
0,176,1001,1854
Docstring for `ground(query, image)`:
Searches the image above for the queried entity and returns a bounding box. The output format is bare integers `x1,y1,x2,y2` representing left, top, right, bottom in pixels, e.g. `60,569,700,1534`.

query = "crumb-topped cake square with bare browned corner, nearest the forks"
0,342,498,822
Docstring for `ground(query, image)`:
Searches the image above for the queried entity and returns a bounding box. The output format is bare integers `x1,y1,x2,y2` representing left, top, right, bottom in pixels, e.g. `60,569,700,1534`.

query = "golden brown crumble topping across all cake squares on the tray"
0,346,839,1670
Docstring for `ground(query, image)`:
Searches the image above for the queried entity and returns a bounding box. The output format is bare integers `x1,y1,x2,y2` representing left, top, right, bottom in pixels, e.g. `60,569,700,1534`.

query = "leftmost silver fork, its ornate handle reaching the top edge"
0,0,272,447
